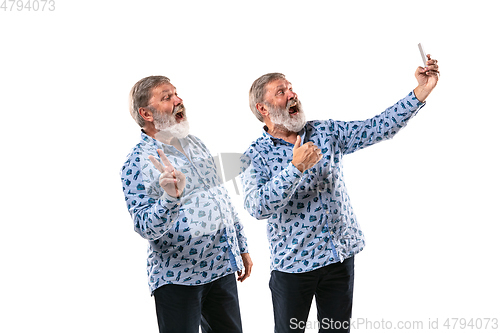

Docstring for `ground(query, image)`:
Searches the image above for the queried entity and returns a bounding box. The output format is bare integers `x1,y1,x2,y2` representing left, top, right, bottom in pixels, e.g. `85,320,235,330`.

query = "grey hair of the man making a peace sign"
129,75,170,128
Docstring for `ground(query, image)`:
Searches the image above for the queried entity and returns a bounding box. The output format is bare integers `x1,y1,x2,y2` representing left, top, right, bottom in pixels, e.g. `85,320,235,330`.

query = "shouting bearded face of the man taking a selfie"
264,79,306,132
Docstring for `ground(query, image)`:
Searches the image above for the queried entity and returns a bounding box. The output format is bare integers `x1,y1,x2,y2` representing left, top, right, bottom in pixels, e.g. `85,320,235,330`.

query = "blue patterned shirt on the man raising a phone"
240,92,425,273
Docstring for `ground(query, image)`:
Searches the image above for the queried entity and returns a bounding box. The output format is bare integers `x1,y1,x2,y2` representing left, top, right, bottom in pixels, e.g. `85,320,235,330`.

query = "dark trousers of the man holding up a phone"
269,257,354,333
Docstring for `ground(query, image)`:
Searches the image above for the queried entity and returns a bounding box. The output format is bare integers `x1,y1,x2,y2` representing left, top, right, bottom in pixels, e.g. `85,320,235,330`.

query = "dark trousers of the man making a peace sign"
154,274,242,333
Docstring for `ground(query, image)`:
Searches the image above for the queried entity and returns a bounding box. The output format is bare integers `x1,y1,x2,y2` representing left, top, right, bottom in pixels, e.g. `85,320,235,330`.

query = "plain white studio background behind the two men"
0,0,500,333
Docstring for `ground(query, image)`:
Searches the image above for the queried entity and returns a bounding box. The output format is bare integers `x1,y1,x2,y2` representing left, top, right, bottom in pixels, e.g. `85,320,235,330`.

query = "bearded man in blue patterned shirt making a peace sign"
121,76,252,333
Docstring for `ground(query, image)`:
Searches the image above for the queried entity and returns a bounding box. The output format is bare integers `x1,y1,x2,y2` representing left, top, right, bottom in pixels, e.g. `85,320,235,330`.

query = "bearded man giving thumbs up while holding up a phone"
241,55,439,333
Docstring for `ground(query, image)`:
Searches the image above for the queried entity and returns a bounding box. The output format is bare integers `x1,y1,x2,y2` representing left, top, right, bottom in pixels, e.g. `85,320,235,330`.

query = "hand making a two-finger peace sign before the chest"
149,149,186,198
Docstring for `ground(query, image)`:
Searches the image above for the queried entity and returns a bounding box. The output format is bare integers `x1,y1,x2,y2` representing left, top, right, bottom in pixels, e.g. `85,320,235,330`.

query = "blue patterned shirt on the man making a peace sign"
121,133,248,292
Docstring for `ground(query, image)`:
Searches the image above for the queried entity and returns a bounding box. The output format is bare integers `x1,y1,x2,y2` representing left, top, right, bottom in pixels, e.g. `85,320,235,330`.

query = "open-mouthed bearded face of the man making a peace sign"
148,83,189,138
